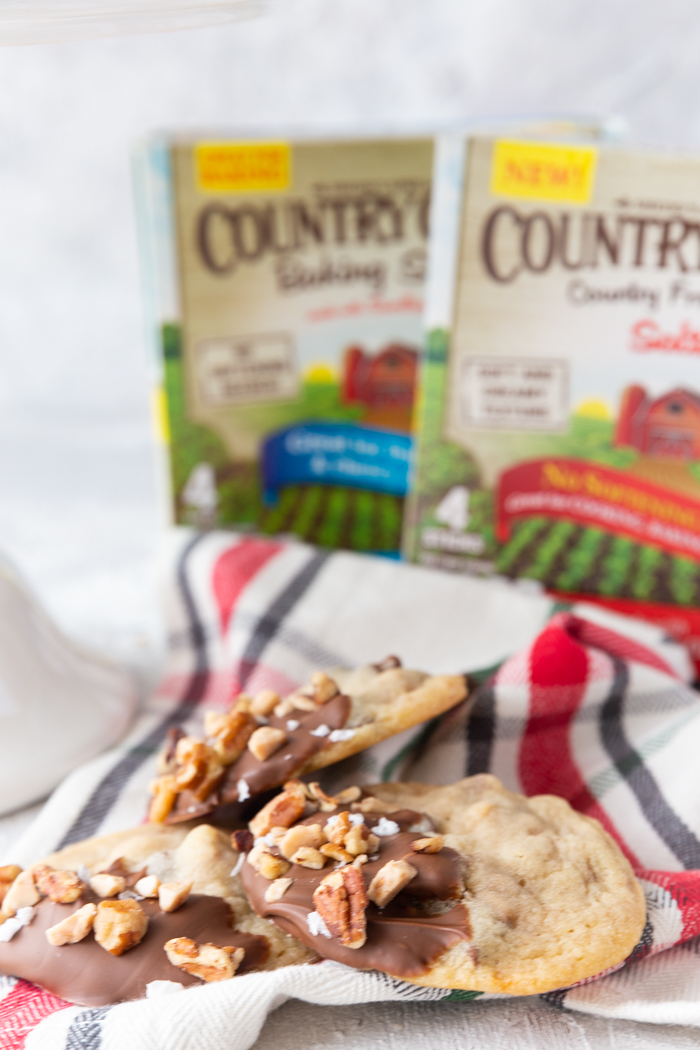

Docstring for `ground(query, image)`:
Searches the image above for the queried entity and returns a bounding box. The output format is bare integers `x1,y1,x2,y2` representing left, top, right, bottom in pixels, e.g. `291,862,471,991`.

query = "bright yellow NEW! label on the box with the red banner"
491,139,598,204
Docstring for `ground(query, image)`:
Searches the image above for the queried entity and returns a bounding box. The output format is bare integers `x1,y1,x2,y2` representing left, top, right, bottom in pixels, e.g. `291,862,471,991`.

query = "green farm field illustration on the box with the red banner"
405,331,700,606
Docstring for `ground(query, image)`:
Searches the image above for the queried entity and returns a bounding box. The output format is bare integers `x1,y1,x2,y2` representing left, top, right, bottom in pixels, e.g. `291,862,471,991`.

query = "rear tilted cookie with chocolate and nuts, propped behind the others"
149,657,467,824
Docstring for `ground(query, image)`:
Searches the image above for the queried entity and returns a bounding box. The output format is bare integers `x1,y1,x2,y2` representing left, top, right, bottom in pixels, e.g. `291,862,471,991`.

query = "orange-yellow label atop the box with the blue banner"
194,142,292,193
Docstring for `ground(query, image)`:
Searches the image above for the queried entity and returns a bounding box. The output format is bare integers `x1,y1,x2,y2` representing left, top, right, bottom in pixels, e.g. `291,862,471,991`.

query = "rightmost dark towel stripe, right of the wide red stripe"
600,654,700,868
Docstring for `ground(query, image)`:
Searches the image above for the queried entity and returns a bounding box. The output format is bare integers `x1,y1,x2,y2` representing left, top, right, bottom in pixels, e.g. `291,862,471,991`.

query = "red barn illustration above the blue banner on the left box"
340,342,418,431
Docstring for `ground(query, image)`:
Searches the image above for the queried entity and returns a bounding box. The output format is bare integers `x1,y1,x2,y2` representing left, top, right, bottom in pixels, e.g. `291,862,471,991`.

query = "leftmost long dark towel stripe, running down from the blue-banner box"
57,532,209,849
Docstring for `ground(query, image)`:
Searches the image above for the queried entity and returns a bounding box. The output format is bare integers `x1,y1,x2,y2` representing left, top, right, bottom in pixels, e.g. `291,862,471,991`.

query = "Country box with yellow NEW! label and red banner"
404,137,700,658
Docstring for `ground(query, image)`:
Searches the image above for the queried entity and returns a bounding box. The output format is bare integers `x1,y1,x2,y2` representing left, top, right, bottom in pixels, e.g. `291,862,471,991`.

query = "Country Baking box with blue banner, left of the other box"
135,137,433,552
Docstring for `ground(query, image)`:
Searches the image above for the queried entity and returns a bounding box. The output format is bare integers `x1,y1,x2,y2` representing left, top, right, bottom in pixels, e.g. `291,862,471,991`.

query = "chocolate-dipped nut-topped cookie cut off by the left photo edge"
0,824,316,1006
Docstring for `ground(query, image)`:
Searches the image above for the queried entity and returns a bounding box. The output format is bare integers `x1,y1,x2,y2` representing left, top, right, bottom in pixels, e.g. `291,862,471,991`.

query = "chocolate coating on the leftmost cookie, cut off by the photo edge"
0,890,270,1006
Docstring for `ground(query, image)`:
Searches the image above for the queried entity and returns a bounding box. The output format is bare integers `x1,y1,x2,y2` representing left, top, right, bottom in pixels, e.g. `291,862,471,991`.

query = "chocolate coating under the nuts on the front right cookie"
241,806,471,978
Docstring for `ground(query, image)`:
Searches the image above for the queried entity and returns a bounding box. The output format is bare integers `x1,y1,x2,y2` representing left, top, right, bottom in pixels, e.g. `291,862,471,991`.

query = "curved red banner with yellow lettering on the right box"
496,458,700,562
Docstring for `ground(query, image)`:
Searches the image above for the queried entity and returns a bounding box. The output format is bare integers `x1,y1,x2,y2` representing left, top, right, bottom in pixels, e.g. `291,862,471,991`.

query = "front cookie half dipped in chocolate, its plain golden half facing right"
238,775,645,995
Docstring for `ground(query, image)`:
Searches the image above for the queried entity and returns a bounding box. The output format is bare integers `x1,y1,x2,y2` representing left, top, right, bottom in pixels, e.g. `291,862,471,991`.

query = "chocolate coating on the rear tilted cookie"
166,693,351,824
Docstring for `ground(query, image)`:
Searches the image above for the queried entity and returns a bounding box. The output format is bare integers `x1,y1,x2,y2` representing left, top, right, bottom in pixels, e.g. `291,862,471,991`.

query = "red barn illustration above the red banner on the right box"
613,385,700,462
